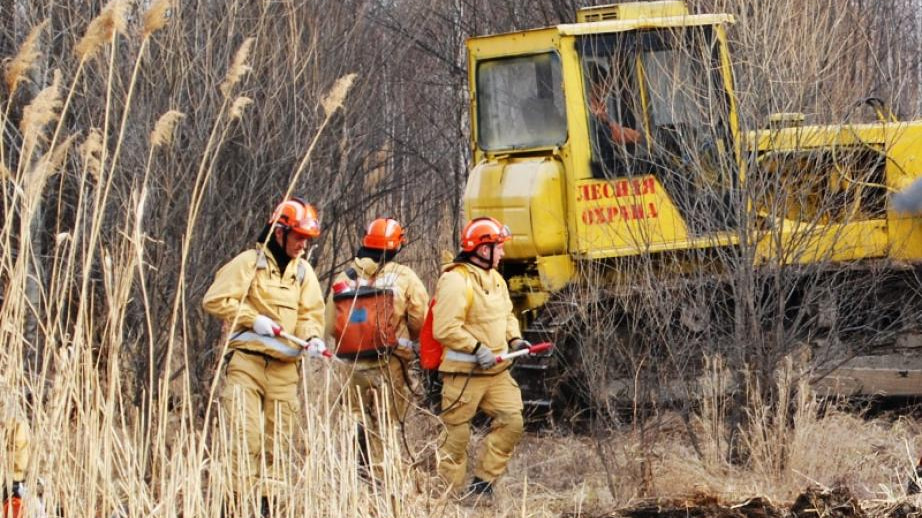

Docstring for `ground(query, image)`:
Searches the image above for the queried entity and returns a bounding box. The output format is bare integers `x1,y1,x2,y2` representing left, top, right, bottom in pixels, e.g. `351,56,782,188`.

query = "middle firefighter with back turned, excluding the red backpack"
326,218,429,484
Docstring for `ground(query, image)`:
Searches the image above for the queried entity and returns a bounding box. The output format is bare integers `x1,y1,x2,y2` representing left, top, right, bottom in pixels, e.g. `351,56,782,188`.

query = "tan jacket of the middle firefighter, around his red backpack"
326,257,429,365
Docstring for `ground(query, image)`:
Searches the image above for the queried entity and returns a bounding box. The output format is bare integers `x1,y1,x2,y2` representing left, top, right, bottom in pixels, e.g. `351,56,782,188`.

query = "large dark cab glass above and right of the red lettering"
578,26,737,233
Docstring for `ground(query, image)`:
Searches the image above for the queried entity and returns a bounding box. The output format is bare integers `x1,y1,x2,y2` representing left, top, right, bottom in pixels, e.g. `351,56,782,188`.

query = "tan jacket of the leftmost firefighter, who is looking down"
202,246,324,362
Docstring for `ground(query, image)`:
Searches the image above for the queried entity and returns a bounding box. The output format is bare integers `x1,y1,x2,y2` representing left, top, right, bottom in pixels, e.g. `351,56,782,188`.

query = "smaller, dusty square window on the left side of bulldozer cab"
477,52,567,151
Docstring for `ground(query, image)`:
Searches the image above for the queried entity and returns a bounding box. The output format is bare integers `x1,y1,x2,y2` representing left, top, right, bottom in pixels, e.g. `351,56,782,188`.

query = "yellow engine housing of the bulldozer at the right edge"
747,122,922,264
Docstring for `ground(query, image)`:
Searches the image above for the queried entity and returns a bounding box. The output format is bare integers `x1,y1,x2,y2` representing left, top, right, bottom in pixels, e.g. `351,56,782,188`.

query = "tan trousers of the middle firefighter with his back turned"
348,355,412,479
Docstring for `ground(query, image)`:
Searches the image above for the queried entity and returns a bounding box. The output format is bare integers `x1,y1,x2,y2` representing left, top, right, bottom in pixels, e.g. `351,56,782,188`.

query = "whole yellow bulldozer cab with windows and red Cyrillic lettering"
465,6,742,278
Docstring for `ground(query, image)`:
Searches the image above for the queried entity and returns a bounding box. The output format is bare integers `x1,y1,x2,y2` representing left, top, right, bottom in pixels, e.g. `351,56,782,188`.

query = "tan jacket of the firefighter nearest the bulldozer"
432,263,522,374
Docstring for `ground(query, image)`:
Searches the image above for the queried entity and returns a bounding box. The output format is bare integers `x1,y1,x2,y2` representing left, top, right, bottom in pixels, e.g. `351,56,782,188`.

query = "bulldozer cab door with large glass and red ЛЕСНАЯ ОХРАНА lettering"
577,26,739,255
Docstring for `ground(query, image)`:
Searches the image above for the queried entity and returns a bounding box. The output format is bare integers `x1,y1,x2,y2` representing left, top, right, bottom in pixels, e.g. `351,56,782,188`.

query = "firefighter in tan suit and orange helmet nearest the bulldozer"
432,218,530,504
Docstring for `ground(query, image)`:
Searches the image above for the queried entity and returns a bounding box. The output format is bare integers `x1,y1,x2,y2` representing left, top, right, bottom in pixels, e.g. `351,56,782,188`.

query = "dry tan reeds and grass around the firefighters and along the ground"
0,0,922,517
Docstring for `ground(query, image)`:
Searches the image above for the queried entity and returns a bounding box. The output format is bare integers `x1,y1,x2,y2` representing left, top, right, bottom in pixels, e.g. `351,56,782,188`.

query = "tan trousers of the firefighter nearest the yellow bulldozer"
439,370,524,489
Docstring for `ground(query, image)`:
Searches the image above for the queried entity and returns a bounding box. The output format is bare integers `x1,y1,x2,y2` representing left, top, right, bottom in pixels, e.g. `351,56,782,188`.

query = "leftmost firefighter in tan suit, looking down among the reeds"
202,198,326,515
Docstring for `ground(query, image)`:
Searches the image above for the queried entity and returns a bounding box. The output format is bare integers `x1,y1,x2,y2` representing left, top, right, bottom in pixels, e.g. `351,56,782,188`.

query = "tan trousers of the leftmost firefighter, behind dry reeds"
221,350,299,496
